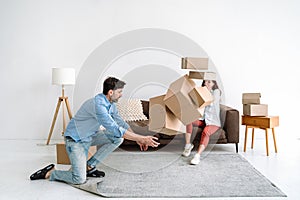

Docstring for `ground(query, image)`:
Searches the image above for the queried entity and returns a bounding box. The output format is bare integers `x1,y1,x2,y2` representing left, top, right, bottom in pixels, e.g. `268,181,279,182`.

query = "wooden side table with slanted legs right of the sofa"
242,115,279,156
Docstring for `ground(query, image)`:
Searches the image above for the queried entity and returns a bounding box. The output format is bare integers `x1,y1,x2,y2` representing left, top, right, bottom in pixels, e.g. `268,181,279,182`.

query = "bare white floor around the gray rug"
0,138,300,200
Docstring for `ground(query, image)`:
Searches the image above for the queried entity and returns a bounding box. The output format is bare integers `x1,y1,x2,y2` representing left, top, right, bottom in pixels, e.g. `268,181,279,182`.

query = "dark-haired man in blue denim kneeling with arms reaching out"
30,77,159,184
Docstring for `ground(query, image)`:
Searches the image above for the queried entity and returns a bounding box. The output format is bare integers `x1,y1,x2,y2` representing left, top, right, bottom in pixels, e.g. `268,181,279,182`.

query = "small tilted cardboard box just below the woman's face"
189,87,214,108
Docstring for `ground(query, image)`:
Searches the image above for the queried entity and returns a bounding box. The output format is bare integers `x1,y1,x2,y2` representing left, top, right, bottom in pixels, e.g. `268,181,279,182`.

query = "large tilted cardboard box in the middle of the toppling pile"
164,75,204,125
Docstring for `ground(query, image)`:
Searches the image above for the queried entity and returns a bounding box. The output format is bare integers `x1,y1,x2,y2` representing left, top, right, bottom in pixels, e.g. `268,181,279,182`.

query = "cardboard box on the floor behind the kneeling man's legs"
56,143,97,165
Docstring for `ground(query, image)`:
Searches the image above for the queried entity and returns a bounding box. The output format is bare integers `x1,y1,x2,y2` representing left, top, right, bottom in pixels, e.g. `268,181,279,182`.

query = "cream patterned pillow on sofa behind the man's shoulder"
116,98,147,122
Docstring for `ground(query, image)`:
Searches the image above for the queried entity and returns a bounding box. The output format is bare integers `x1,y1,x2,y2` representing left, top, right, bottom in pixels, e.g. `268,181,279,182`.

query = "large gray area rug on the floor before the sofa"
73,152,286,198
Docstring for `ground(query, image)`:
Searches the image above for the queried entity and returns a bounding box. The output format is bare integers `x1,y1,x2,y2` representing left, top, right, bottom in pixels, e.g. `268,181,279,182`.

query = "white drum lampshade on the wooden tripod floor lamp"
52,68,75,85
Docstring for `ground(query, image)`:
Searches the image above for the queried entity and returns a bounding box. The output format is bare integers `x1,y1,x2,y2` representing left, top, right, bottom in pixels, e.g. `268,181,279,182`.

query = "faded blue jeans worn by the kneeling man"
50,132,123,184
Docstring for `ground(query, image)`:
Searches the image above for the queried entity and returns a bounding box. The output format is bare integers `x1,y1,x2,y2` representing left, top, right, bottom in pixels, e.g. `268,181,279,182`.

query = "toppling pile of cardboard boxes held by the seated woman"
149,57,216,135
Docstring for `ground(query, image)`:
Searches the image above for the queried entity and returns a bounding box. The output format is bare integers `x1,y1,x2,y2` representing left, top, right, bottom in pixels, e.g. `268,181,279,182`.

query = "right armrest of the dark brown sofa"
220,105,240,143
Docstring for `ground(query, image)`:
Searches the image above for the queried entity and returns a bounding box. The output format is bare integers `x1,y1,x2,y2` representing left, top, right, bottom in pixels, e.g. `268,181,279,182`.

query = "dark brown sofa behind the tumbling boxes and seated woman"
121,100,240,152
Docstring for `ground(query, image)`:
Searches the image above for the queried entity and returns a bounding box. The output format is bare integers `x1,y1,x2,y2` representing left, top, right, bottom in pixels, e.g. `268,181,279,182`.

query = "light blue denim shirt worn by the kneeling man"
64,94,129,142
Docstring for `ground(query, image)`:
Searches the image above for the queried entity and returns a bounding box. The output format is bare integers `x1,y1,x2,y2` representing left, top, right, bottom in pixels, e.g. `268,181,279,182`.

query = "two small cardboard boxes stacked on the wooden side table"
242,93,268,116
